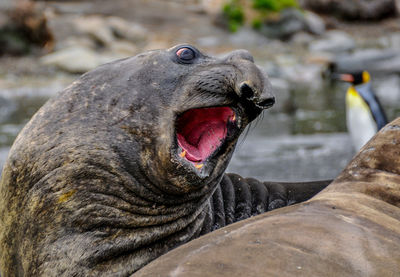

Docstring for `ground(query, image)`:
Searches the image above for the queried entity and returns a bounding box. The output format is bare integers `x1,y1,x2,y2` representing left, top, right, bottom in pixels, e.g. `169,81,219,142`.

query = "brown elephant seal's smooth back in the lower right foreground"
135,118,400,277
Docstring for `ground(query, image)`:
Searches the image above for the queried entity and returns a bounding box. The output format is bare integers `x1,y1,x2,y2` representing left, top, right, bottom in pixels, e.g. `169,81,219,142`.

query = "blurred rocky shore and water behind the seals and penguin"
0,0,400,181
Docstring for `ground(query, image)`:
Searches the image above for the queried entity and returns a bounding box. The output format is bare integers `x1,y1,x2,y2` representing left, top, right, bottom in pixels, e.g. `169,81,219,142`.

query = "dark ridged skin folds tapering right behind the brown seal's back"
206,173,332,230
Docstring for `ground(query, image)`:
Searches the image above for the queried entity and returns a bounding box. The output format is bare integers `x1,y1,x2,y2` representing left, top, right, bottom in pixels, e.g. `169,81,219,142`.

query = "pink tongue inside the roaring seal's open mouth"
177,120,226,162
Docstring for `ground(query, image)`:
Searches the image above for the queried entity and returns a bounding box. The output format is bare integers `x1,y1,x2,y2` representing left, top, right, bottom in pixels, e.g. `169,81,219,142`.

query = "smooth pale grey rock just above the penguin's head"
309,30,356,54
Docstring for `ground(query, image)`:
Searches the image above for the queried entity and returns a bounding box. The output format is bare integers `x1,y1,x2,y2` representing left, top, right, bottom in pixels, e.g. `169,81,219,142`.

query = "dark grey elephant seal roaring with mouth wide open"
0,45,328,277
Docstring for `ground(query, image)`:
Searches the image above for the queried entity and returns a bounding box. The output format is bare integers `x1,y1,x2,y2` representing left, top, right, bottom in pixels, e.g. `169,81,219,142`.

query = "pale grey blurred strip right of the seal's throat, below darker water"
228,133,353,181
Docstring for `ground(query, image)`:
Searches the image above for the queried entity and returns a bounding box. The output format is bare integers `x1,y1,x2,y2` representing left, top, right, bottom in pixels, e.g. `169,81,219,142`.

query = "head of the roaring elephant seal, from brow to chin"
119,45,275,192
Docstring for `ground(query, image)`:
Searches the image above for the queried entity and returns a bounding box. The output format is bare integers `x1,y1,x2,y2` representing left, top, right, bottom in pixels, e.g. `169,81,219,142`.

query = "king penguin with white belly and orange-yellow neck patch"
339,71,388,150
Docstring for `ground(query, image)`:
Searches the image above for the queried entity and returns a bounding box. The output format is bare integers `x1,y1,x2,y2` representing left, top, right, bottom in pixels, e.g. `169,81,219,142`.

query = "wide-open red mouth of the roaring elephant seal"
176,107,236,164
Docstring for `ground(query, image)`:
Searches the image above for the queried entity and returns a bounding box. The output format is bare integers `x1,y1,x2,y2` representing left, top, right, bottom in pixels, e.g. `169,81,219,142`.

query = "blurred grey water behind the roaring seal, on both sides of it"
0,75,400,181
